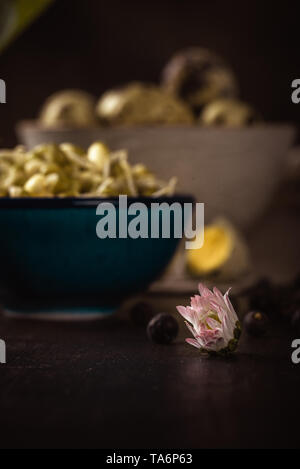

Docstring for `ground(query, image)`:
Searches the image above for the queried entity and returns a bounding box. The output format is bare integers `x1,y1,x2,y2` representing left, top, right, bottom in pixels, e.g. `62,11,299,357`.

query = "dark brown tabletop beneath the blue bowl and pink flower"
0,187,300,449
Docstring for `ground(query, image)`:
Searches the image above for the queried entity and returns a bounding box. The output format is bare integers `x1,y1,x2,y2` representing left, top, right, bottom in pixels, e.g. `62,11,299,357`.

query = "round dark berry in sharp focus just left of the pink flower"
147,313,179,344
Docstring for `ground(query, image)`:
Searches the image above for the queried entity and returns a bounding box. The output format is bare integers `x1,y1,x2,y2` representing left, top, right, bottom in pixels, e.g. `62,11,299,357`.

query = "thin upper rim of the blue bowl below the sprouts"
0,194,195,209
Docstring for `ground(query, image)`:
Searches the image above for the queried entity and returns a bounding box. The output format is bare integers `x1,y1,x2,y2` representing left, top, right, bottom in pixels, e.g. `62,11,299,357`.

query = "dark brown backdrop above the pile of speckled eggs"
0,0,300,146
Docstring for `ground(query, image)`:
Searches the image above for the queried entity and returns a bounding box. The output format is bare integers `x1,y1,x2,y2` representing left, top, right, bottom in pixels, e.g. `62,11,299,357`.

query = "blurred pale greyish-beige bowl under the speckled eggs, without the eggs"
17,122,295,228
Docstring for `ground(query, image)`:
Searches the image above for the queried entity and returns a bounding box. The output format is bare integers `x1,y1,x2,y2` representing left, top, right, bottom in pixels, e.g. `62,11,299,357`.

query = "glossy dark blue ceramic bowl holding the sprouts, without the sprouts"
0,196,193,318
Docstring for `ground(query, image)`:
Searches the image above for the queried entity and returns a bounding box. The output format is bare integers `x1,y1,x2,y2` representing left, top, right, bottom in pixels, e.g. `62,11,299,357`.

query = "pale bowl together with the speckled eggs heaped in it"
17,47,295,229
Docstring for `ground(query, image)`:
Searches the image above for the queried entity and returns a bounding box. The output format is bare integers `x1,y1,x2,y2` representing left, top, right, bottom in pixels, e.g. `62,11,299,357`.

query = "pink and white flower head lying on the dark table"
177,283,241,353
